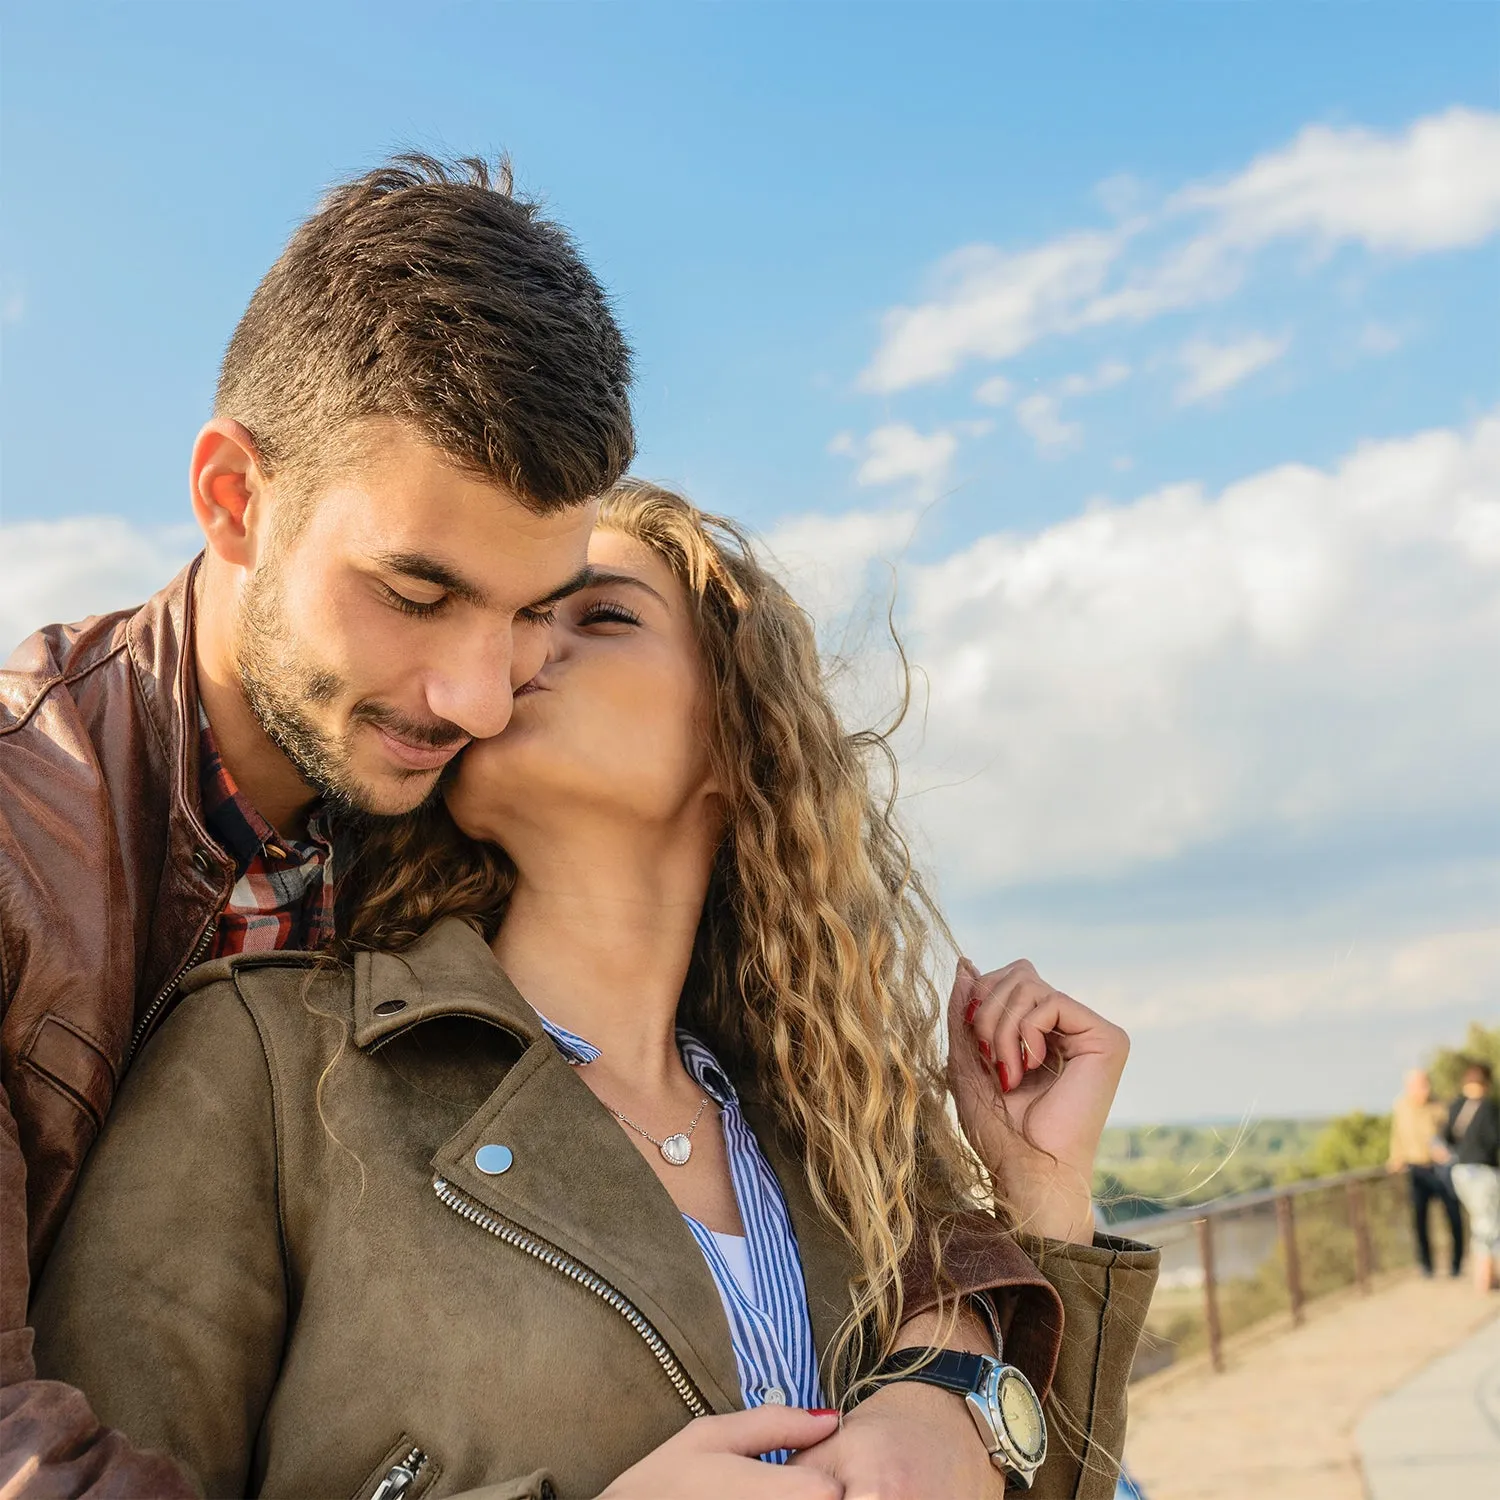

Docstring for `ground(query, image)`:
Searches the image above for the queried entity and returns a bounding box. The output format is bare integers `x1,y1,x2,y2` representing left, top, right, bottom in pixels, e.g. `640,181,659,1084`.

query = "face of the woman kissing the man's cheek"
447,531,716,861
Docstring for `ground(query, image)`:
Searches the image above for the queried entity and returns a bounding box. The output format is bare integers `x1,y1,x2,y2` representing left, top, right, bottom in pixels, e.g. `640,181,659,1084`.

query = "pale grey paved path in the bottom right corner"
1355,1319,1500,1500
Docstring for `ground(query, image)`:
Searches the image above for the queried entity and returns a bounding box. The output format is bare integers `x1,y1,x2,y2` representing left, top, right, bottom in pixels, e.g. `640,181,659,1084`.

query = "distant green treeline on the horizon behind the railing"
1094,1022,1500,1223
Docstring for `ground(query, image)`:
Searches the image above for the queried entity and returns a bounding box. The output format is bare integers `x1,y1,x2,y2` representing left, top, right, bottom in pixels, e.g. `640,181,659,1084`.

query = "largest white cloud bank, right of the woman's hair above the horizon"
783,411,1500,1118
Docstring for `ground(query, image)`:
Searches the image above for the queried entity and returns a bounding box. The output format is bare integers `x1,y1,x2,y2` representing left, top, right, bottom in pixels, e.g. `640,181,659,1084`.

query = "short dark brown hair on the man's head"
215,153,635,515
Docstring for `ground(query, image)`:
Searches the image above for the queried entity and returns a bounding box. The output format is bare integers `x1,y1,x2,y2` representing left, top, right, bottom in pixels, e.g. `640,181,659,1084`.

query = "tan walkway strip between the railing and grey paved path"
1125,1275,1500,1500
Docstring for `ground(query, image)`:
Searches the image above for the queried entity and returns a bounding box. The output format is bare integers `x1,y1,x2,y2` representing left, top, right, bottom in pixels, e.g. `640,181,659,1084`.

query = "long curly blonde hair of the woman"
341,479,992,1394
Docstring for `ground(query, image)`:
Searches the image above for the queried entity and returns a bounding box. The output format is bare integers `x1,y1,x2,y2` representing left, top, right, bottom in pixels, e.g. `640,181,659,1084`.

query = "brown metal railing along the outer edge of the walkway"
1109,1167,1446,1377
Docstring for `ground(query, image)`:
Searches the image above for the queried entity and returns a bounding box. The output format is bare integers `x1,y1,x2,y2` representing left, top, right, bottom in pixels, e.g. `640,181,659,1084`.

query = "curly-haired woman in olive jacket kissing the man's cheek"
36,483,1155,1500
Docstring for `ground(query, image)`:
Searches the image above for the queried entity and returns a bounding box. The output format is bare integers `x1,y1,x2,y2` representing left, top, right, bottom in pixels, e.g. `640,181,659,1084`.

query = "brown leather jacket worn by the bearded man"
0,563,1155,1500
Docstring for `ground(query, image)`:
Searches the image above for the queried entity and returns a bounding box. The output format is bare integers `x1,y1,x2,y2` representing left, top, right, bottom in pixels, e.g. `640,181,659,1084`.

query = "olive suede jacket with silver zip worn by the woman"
33,921,1157,1500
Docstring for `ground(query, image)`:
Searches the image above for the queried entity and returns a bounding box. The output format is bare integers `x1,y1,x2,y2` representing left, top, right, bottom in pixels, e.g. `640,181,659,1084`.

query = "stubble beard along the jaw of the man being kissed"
236,561,444,825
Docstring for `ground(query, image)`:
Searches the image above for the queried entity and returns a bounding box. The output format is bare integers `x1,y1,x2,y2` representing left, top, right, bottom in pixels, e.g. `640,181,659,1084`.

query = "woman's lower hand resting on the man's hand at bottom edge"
599,1406,845,1500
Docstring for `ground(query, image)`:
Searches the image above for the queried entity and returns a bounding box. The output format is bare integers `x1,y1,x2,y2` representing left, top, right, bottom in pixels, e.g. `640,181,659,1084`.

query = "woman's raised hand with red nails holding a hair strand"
948,959,1130,1244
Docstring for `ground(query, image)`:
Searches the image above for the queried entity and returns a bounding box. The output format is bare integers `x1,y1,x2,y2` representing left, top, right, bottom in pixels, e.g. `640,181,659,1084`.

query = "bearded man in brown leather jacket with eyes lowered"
0,158,633,1496
